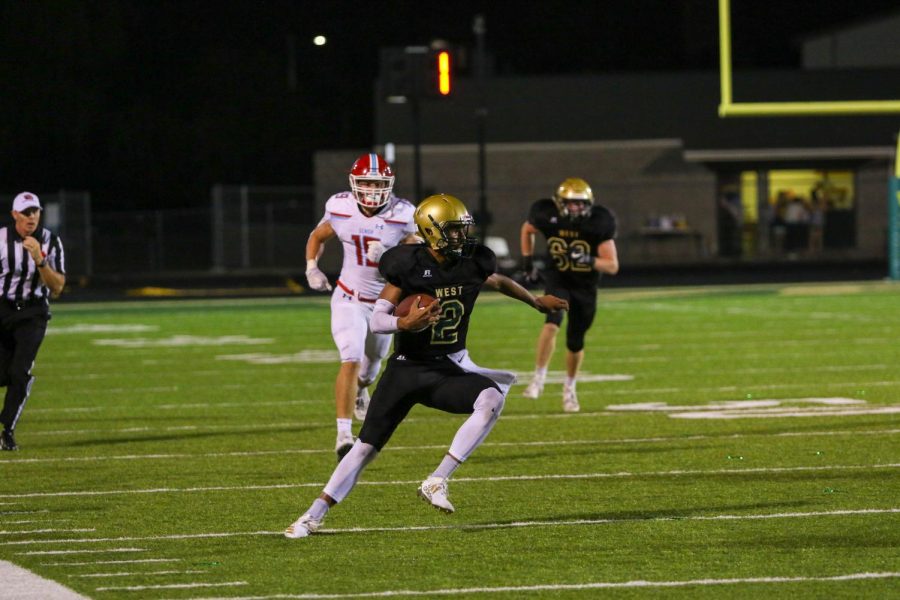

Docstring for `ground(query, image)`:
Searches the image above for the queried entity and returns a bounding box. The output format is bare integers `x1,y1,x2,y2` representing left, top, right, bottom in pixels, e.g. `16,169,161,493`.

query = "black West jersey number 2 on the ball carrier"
378,244,497,359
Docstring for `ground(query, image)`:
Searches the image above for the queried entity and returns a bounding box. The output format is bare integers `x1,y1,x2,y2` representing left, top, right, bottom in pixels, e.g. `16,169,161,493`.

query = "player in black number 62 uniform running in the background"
520,177,619,412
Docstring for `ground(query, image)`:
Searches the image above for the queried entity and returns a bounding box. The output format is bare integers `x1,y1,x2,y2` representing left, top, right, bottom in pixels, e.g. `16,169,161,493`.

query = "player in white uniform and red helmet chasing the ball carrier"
306,153,418,462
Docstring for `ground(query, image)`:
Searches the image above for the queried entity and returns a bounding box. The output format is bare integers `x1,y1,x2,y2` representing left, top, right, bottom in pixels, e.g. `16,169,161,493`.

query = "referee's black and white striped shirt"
0,225,66,304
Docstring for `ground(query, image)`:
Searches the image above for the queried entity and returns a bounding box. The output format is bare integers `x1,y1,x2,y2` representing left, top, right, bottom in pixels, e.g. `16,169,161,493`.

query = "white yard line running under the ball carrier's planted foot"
0,508,900,548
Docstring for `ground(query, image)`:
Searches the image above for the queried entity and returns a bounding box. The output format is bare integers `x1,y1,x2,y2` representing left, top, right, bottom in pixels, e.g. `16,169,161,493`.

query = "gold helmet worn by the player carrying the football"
413,194,478,256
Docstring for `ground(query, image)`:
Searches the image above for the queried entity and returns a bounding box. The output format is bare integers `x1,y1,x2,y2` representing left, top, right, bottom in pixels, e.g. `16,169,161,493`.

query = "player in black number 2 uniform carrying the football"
284,194,568,538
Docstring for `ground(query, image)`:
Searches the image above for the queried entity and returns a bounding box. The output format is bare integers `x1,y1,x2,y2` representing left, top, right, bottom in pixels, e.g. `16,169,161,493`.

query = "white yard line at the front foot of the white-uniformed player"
0,428,900,466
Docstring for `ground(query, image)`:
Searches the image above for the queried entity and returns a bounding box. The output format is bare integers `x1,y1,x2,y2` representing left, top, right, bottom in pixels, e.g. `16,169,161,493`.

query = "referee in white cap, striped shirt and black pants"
0,192,66,450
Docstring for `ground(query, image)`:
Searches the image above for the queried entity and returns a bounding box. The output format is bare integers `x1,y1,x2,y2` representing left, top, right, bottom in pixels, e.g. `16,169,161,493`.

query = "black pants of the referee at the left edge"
0,315,47,429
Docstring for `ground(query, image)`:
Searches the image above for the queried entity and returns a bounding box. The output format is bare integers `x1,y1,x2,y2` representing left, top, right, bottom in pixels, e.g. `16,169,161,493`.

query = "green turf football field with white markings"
0,283,900,599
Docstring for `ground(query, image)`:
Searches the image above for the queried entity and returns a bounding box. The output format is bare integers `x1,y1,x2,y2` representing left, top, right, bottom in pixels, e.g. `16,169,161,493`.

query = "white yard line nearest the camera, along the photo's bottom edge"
183,572,900,600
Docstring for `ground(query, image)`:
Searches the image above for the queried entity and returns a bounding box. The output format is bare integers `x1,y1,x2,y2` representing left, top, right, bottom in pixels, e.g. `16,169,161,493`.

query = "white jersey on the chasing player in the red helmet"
319,192,417,300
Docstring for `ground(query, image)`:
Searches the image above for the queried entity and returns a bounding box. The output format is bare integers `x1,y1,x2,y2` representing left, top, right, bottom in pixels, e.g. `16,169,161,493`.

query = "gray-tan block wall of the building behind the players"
315,140,716,270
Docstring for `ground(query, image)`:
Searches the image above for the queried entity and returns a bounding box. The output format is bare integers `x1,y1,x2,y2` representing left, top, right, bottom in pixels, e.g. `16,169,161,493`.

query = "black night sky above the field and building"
0,0,896,211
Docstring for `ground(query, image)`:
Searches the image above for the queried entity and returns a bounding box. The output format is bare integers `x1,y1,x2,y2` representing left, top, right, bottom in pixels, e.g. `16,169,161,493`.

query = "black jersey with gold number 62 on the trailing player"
528,198,616,288
